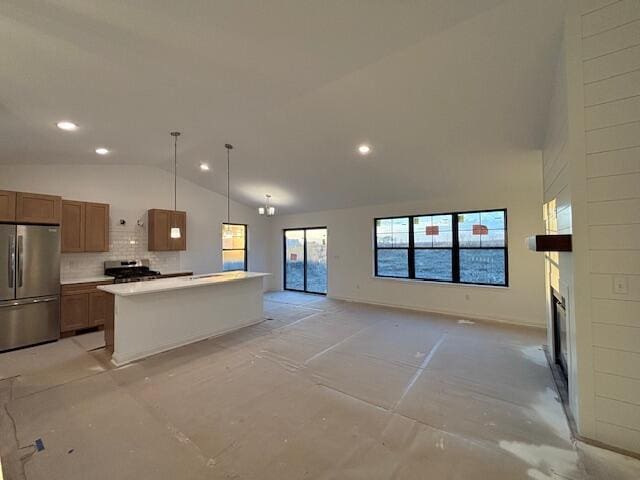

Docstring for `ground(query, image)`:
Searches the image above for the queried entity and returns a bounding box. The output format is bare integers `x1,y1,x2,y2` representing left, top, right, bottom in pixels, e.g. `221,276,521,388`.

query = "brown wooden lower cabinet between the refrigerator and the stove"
60,282,114,332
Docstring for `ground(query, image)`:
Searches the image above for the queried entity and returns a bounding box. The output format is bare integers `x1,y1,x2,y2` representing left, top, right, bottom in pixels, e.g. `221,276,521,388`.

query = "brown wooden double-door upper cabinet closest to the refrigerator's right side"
61,200,109,253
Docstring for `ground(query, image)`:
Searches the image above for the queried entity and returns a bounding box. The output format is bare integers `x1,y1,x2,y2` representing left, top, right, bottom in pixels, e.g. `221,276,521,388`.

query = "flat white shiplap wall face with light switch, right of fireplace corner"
581,0,640,452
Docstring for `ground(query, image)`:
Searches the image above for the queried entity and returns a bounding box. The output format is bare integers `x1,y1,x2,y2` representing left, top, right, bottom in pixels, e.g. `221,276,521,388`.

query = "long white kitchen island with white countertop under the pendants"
98,272,269,366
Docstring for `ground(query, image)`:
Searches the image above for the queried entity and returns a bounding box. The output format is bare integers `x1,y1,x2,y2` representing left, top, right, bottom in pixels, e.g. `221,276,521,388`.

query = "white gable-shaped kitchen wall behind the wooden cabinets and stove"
0,165,269,276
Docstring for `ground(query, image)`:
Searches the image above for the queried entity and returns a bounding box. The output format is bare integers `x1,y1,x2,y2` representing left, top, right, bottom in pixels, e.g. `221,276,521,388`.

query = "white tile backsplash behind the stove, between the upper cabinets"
60,224,180,279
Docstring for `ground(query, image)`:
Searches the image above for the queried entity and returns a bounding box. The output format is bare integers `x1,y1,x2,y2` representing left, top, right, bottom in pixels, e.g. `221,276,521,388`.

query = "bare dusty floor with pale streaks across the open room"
0,293,640,480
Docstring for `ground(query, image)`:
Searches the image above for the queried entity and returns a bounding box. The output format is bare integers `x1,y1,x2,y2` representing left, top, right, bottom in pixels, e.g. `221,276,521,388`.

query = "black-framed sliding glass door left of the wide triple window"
284,227,327,294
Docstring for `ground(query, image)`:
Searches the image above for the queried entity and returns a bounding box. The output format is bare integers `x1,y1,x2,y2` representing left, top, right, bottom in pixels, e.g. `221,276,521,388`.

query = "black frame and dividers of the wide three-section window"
373,208,509,288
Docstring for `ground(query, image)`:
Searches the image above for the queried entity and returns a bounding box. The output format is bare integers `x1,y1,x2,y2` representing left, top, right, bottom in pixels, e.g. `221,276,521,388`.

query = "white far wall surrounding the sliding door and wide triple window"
270,151,545,326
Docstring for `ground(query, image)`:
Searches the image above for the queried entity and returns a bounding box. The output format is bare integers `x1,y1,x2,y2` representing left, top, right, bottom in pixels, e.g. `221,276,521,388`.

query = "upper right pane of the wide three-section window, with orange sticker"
458,211,505,247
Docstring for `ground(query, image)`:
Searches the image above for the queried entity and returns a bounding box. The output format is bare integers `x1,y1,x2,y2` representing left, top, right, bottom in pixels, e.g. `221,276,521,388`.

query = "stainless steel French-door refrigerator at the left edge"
0,224,60,352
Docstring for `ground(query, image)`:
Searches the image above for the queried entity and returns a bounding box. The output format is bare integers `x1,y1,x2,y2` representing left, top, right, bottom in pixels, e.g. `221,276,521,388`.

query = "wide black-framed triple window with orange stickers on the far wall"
375,210,508,286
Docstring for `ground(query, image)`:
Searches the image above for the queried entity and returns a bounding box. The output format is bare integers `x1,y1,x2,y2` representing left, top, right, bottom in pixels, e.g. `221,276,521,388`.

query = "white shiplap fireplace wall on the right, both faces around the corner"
544,0,640,453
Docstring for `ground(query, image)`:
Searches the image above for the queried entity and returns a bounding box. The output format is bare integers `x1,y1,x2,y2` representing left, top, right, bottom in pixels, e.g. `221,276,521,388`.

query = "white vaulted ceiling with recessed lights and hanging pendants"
0,0,563,212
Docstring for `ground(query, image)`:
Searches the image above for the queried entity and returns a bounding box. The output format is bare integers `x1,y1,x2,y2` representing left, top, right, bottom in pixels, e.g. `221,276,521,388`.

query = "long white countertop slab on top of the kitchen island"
98,272,271,297
